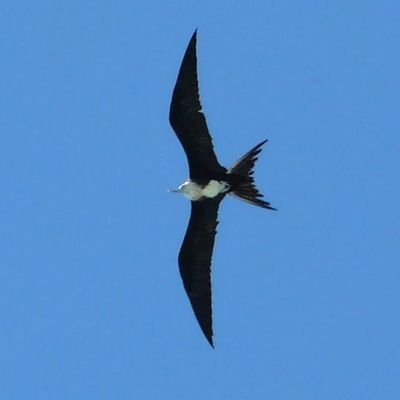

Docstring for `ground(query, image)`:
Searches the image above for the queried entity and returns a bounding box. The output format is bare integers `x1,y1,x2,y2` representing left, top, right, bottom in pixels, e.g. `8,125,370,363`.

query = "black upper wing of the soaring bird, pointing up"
169,31,226,179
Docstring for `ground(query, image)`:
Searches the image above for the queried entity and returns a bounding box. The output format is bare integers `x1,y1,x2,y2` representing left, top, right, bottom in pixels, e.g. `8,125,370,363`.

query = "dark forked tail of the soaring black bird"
228,140,276,210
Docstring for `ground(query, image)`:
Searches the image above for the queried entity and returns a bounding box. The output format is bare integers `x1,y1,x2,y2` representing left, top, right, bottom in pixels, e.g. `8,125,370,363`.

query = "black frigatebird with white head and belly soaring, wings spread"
169,29,276,348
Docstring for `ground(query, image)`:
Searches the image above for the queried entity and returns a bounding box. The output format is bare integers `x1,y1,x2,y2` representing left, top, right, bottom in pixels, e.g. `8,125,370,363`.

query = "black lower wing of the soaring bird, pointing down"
179,195,224,346
